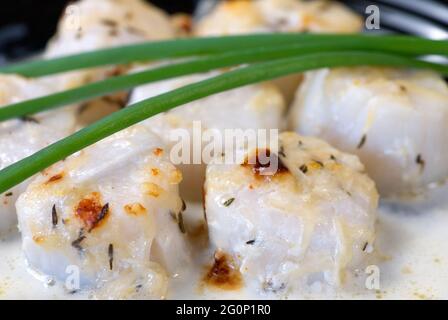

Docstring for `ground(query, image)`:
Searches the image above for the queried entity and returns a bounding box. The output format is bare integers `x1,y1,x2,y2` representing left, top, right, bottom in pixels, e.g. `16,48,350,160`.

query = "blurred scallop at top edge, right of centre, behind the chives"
194,0,362,103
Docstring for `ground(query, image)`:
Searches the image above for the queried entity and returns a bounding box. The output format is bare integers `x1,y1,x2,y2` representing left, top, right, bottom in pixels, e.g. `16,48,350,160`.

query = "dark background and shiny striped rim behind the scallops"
0,0,448,64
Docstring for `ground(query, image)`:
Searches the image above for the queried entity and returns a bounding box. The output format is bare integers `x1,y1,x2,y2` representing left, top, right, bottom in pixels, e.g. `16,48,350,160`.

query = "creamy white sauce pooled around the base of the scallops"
0,196,448,299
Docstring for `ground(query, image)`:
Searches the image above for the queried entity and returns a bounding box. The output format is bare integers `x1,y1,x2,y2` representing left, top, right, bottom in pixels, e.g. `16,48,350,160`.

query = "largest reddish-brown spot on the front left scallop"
75,192,109,232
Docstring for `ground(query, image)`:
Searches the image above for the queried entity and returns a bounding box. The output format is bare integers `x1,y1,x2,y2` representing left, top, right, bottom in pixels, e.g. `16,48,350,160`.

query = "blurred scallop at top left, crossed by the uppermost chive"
45,0,177,89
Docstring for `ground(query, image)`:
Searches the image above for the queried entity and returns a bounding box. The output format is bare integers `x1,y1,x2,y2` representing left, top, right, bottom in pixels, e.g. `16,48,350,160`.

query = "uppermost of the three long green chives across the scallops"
0,33,448,77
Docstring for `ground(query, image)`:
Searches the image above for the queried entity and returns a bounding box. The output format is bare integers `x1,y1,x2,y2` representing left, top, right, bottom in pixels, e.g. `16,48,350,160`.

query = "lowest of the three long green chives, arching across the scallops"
0,52,448,193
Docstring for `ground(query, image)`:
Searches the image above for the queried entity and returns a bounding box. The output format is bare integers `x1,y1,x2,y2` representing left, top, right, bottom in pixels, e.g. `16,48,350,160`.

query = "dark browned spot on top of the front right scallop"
242,149,289,178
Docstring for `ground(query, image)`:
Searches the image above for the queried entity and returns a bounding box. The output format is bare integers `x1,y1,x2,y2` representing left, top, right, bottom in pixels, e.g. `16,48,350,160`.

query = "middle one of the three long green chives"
0,38,448,121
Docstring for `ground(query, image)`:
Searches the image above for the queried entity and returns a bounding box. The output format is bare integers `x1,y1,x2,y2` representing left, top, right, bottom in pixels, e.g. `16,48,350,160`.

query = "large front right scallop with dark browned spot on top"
204,132,378,294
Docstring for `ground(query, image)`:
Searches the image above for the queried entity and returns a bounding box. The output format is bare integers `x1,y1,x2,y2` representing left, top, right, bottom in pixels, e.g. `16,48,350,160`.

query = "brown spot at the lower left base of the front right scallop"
204,251,243,290
